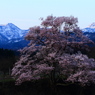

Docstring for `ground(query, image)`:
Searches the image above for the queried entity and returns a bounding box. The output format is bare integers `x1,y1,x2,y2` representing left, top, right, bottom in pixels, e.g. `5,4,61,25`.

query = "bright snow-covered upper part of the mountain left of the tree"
0,23,27,40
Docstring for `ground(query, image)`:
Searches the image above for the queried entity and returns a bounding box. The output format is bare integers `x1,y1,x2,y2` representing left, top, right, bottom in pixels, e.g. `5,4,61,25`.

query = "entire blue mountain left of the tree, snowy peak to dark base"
0,23,29,50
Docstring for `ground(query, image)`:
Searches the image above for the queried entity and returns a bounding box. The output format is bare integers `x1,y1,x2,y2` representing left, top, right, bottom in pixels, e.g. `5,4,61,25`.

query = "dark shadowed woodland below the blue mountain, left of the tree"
0,48,19,75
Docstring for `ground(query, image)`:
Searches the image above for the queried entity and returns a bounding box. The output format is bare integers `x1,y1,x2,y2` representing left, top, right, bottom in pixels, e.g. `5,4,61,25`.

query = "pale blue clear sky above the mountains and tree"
0,0,95,29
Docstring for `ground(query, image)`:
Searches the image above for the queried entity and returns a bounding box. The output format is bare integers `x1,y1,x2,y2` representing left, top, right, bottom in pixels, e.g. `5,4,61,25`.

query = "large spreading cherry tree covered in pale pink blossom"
12,16,95,85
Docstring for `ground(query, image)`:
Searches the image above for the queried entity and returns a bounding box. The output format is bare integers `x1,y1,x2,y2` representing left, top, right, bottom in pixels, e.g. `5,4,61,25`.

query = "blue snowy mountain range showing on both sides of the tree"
0,23,95,50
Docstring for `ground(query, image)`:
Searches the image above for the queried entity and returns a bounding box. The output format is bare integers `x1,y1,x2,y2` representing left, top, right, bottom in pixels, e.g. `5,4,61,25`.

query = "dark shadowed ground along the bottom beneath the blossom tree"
0,78,95,95
